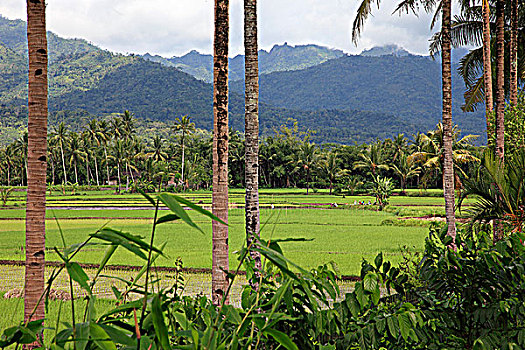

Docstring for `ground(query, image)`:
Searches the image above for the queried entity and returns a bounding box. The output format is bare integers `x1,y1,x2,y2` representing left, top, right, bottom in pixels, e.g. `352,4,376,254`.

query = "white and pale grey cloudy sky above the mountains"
0,0,438,57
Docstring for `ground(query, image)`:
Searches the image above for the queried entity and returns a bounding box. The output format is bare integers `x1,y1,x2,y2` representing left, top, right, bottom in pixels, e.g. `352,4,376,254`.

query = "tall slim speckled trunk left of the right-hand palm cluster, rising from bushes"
441,0,456,244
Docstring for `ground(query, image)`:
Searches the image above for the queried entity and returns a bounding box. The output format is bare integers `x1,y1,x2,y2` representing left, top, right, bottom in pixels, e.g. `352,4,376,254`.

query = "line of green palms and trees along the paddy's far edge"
0,111,480,194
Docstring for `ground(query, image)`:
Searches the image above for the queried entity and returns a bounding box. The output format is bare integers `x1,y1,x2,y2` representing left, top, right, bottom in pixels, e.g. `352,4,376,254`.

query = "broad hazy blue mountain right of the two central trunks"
231,55,484,138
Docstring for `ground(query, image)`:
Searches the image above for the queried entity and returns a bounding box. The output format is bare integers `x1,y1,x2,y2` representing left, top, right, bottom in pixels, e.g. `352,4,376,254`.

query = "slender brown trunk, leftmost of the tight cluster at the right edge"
483,0,494,139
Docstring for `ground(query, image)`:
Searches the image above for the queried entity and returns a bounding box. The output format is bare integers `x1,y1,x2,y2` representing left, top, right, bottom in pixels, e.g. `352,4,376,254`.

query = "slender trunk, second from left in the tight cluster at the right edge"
496,0,505,160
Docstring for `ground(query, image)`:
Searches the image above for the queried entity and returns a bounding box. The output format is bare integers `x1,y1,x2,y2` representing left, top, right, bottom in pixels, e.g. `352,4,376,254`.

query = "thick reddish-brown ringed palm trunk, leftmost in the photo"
24,0,47,330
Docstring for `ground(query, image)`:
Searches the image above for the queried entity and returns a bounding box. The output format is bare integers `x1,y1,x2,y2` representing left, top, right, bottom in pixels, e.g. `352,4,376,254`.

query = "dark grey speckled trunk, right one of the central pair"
244,0,261,290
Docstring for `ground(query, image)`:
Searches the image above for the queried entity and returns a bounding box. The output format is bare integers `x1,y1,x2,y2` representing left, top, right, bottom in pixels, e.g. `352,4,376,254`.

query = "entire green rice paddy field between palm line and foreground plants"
0,189,469,304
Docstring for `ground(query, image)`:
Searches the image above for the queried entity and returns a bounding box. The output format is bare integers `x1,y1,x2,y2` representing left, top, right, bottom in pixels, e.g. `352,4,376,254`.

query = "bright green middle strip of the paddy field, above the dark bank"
0,209,427,275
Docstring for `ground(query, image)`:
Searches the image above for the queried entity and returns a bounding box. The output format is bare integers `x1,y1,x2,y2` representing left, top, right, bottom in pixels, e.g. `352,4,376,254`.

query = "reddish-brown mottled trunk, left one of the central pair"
211,0,229,305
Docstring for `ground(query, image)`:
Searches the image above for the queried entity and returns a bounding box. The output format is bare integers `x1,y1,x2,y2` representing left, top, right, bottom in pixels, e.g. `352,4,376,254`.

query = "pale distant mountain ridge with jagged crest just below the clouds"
142,43,343,83
